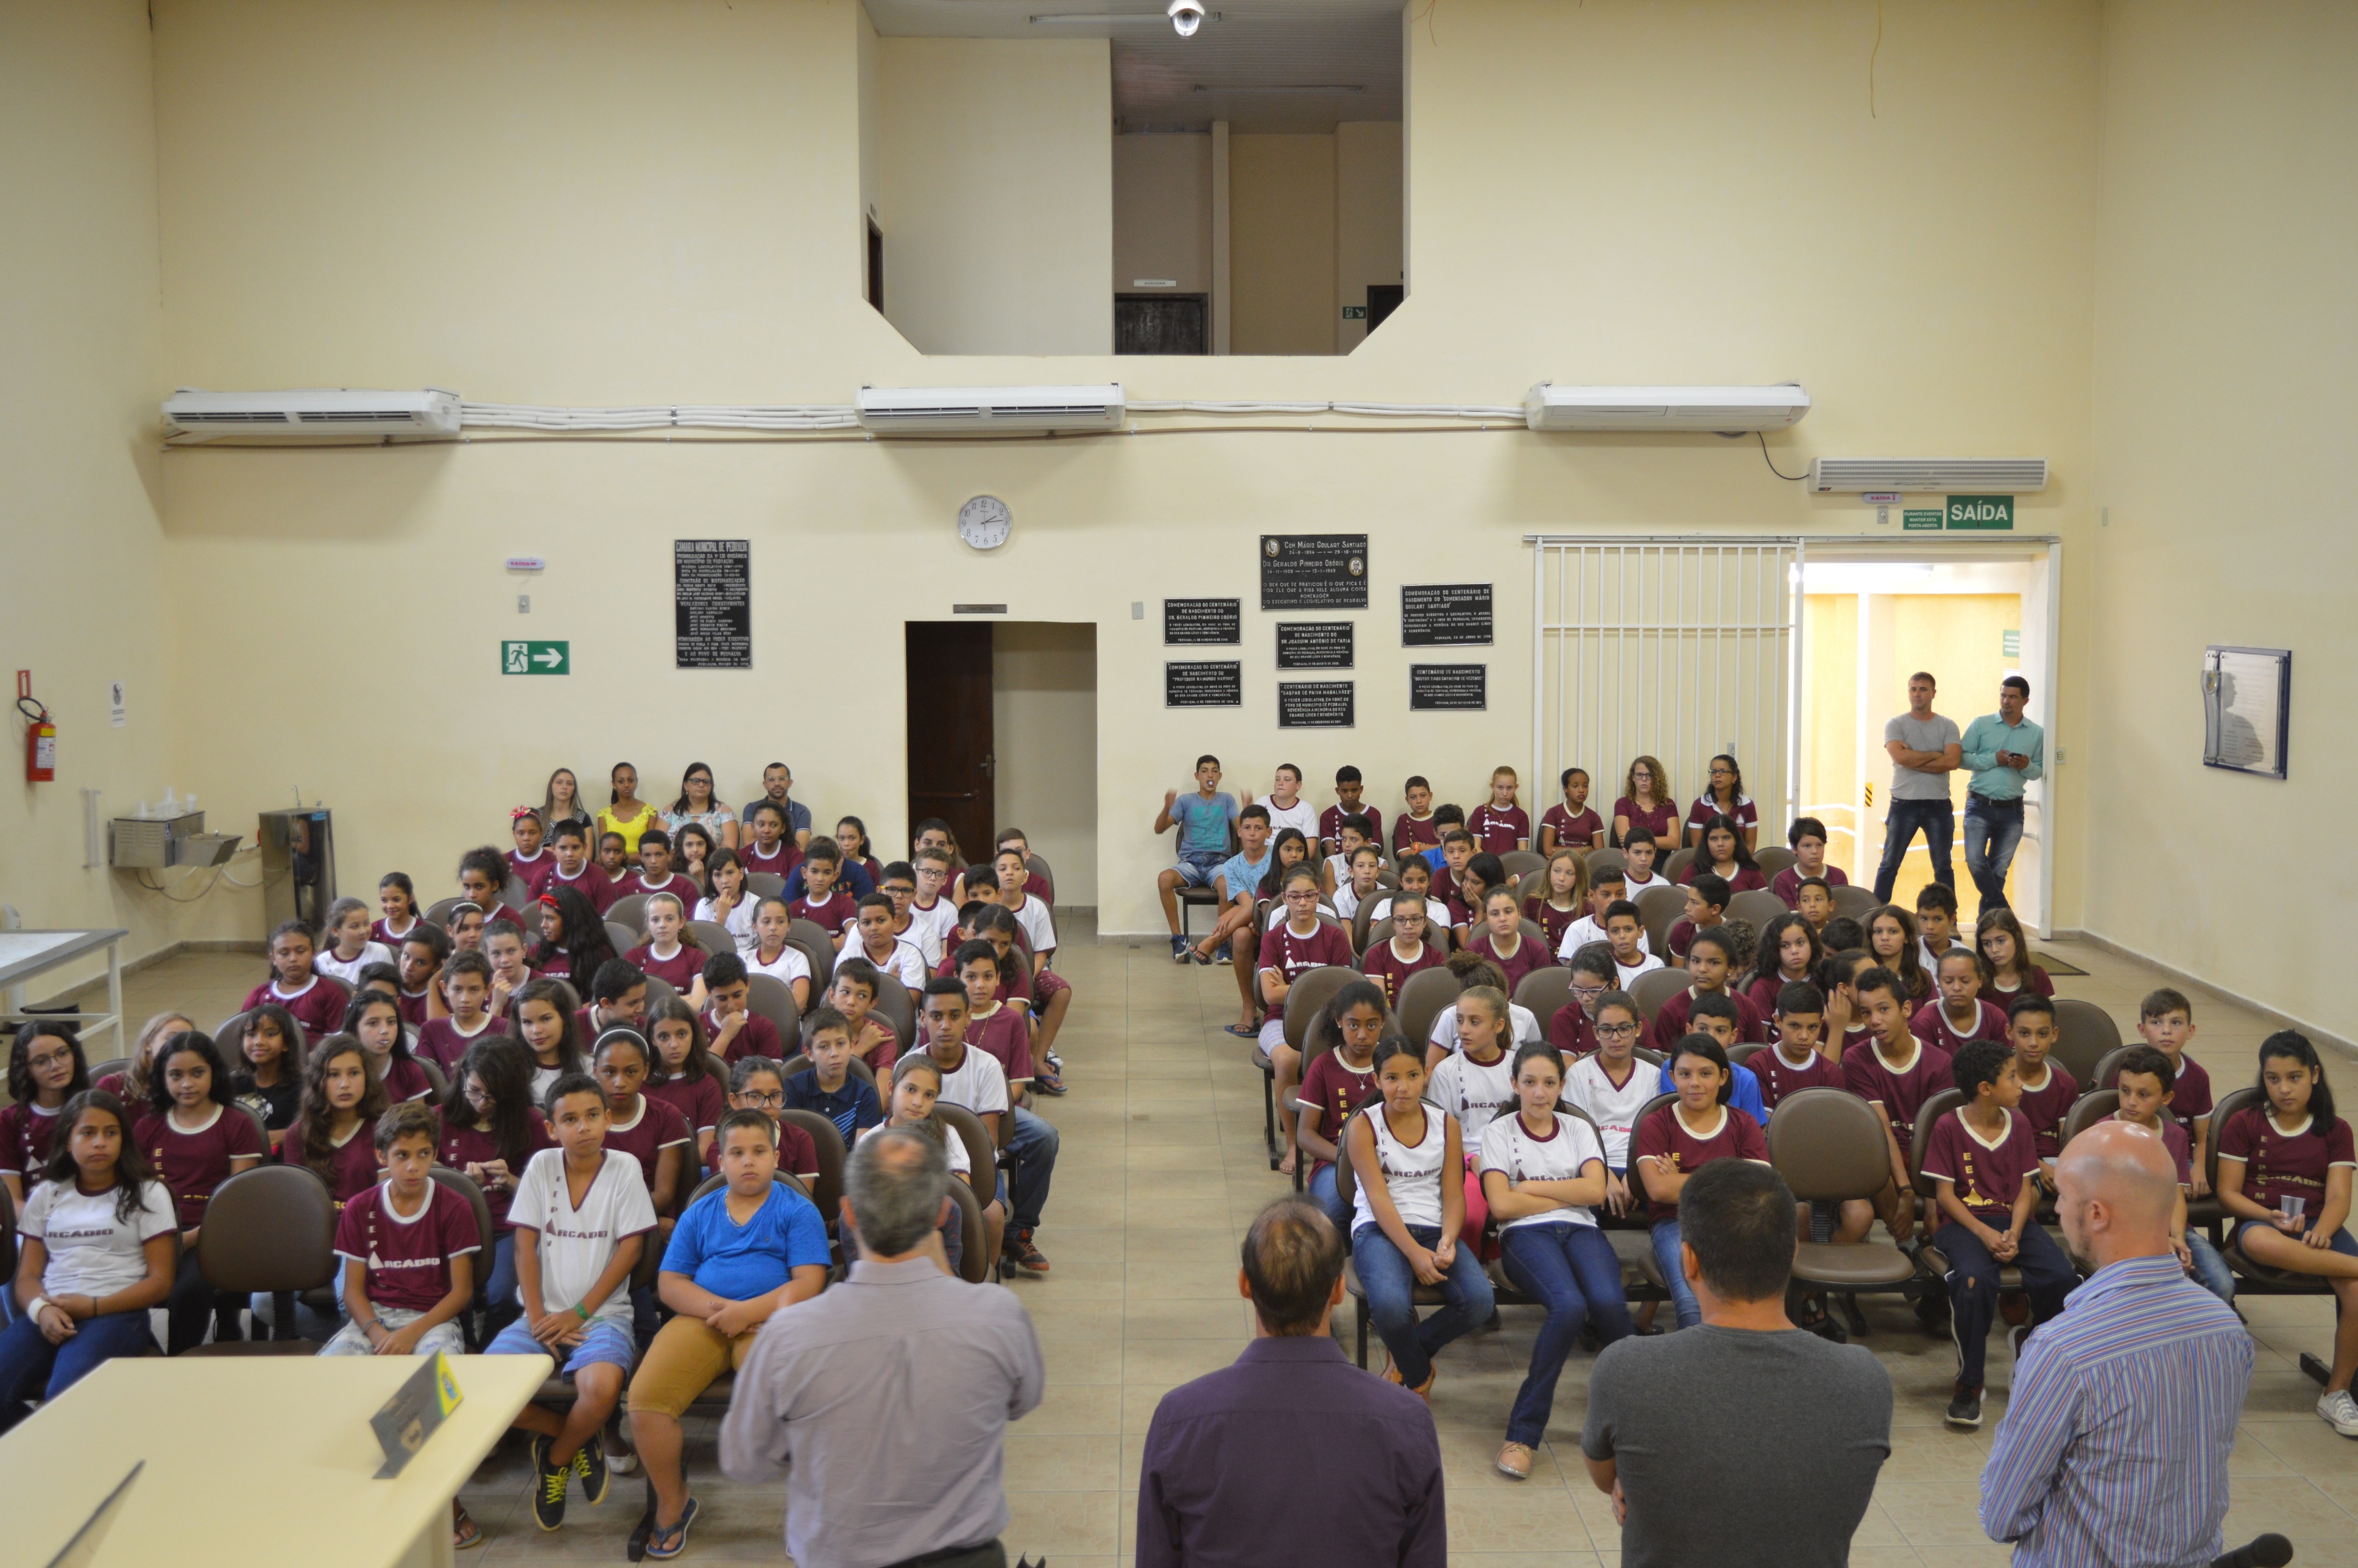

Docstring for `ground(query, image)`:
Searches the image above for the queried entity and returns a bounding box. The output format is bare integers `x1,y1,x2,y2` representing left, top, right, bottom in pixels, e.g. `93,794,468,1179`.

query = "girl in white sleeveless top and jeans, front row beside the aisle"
1344,1035,1492,1403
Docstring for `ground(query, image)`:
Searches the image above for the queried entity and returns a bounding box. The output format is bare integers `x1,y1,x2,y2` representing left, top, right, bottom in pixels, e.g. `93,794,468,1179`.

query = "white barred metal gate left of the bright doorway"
1526,535,1801,844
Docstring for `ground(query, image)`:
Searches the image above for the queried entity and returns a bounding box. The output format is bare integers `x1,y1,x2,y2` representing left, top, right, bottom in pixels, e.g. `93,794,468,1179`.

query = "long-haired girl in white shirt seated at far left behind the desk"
0,1089,179,1433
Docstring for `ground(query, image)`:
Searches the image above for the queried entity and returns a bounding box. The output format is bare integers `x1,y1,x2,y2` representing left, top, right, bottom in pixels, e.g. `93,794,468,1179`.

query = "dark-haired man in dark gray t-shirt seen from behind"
1580,1160,1891,1568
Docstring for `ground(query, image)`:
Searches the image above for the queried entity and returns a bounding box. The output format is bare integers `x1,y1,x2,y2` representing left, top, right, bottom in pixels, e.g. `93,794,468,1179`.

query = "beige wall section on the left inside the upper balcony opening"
877,38,1113,354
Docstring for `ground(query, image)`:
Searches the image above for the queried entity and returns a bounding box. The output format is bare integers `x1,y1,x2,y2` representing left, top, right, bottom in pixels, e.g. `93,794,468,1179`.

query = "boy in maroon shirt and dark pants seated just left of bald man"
1924,1040,2080,1427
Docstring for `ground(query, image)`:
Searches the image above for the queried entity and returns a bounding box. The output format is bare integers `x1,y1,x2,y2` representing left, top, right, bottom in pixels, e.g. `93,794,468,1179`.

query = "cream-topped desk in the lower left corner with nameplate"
0,1356,552,1568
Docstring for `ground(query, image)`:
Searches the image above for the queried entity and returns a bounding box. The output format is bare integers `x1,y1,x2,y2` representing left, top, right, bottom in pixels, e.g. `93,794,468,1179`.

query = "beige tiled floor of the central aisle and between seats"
41,929,2358,1568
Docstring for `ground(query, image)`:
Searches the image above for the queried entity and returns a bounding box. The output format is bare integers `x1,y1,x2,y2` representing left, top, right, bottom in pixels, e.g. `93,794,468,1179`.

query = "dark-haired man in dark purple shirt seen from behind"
1139,1198,1450,1568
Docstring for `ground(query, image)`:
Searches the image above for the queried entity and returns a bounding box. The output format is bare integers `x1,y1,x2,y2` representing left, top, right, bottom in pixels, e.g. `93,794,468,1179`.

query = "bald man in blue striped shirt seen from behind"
1981,1122,2252,1568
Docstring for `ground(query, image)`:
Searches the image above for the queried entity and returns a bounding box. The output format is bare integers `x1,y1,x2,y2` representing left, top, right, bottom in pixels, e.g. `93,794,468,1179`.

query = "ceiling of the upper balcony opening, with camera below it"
868,0,1403,132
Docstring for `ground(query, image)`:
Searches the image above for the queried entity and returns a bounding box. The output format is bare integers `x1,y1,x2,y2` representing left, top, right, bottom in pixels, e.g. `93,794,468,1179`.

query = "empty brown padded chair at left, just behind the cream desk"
182,1165,337,1356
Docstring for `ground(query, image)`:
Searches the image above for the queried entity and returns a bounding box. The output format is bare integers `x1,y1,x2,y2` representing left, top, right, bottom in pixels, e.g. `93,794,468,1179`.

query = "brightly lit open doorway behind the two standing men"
1799,540,2056,936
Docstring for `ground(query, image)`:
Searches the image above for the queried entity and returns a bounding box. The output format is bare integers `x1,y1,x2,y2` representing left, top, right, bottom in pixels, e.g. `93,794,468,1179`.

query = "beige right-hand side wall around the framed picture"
2068,0,2358,1040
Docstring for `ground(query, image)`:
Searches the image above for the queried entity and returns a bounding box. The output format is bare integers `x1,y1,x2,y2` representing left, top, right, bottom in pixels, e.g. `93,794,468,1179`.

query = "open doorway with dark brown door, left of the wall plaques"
903,620,1096,910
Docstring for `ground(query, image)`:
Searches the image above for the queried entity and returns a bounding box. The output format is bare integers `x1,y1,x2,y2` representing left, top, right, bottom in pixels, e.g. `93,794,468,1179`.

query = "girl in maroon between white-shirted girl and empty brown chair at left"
132,1028,264,1356
